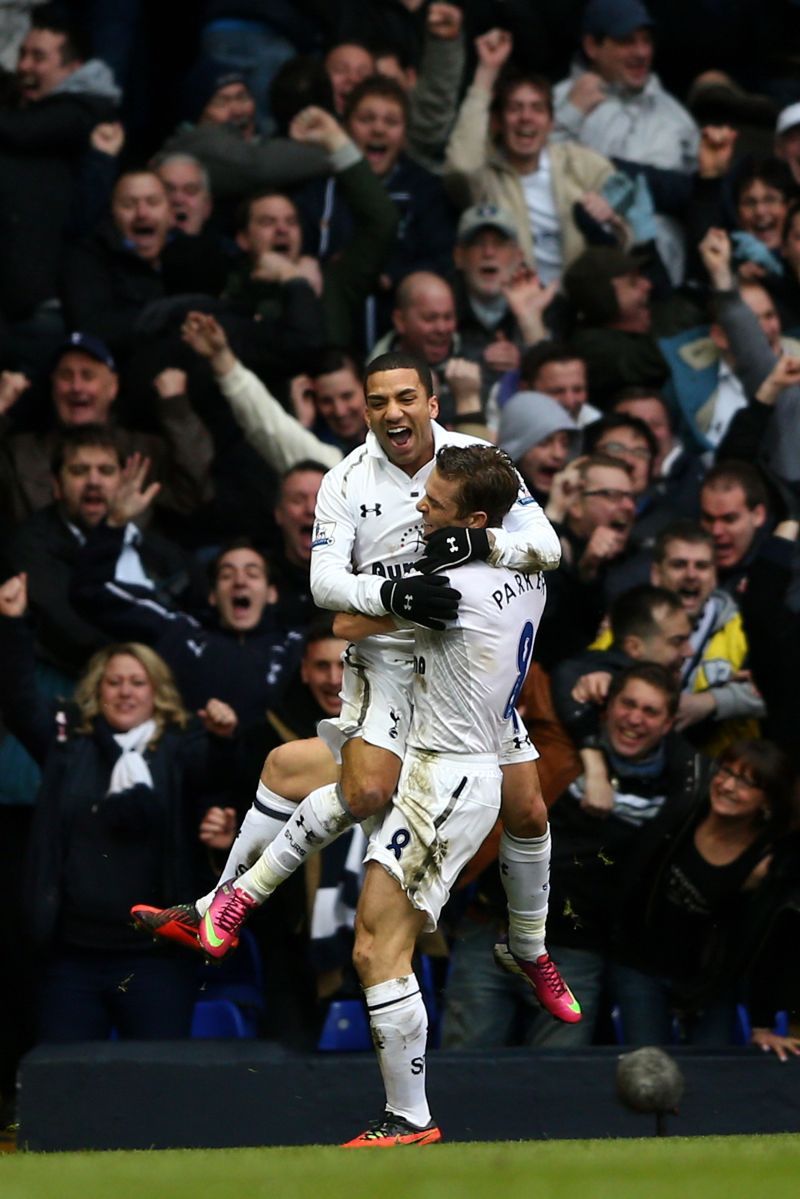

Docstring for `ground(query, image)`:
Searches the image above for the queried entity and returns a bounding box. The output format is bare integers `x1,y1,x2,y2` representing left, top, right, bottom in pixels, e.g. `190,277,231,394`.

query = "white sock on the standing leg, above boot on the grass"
363,975,431,1128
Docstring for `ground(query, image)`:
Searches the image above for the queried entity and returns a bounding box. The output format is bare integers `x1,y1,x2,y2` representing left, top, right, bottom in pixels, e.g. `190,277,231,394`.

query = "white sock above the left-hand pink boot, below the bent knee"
236,783,356,900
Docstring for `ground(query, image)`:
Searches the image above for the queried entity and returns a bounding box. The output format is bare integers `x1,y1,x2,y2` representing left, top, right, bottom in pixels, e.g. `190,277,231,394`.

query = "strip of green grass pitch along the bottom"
0,1135,800,1199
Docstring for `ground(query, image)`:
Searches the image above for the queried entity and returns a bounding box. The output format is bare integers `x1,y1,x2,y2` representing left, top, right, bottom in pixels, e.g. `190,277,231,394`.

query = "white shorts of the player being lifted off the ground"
317,645,539,766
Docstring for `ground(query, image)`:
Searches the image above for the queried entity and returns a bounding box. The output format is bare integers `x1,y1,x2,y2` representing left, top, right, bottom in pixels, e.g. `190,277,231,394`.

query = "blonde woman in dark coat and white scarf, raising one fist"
0,576,236,1042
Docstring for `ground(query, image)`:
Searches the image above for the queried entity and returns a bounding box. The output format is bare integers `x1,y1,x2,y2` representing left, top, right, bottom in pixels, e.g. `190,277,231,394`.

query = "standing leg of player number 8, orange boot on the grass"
345,862,441,1149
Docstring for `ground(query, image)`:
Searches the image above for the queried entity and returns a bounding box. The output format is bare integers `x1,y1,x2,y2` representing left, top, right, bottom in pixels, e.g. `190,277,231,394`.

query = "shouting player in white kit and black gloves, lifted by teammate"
133,353,581,1050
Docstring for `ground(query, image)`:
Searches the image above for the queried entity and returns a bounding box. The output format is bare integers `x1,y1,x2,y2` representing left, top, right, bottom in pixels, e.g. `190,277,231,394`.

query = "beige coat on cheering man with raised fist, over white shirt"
444,85,614,267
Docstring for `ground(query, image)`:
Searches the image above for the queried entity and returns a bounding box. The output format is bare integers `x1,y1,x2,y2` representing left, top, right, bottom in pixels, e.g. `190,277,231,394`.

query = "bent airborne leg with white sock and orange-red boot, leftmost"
131,737,338,950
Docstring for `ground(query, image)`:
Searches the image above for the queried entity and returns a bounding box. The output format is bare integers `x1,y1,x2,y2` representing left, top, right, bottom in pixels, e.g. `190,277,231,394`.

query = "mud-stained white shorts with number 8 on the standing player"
365,749,503,932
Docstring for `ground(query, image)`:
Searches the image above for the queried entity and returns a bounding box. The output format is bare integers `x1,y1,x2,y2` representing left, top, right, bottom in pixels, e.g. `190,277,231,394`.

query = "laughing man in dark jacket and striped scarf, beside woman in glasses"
444,663,697,1049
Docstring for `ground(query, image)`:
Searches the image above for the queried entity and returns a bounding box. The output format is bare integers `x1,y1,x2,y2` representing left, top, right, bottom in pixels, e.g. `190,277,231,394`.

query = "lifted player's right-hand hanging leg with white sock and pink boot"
495,759,581,1024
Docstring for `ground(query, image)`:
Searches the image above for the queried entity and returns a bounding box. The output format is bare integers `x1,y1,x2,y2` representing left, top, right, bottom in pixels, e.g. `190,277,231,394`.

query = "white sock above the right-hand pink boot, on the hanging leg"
499,825,551,962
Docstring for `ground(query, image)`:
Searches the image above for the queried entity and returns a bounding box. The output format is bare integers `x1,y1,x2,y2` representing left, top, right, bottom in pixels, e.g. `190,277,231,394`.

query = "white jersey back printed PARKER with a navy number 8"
408,562,547,754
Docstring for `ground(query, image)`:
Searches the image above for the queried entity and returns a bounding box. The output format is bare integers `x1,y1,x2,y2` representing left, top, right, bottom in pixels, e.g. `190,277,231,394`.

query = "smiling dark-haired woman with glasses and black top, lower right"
612,740,796,1052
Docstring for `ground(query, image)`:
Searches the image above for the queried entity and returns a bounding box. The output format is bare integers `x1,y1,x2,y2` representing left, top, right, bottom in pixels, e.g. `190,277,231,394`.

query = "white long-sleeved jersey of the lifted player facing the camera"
311,421,561,653
